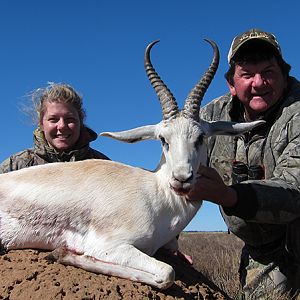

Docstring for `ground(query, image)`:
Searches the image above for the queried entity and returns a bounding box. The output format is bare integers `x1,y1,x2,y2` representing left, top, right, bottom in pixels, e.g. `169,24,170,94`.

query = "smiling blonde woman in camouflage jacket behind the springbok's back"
0,84,109,173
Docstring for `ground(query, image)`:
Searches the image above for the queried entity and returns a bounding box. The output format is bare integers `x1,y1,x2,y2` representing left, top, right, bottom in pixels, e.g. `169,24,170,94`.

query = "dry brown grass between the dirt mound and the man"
179,232,243,299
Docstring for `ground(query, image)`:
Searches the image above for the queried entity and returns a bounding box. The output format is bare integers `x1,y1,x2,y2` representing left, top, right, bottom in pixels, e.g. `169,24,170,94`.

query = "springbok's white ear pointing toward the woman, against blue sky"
99,125,156,143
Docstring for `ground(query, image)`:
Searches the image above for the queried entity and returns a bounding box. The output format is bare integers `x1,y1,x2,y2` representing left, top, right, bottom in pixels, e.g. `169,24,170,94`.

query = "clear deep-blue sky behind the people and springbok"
0,0,300,231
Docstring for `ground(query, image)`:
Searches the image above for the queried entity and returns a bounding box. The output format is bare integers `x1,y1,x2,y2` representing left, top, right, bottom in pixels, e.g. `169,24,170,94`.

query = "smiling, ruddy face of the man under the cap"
228,58,287,120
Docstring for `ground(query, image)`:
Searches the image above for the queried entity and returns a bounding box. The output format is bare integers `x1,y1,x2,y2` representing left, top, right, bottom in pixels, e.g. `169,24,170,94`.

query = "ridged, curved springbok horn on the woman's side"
144,40,179,120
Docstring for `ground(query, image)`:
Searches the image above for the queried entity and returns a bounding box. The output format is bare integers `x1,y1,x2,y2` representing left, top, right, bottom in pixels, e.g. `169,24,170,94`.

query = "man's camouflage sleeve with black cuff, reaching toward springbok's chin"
224,114,300,224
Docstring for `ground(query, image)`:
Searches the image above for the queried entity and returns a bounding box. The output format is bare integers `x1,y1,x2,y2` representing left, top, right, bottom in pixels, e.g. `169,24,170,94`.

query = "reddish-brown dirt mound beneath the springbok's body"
0,249,228,300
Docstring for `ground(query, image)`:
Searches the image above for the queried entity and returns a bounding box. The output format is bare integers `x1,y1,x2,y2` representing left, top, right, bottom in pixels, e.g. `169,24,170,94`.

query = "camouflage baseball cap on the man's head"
228,28,282,63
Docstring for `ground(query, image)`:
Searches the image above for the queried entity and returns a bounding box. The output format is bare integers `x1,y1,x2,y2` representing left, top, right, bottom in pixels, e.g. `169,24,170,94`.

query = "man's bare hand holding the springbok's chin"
186,166,237,207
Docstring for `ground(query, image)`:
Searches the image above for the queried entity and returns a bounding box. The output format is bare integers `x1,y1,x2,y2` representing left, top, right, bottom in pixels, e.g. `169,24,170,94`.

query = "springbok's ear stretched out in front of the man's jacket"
201,120,266,136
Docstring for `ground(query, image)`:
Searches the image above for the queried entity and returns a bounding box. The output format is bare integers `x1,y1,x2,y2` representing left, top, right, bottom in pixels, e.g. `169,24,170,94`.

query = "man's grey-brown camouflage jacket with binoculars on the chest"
200,77,300,256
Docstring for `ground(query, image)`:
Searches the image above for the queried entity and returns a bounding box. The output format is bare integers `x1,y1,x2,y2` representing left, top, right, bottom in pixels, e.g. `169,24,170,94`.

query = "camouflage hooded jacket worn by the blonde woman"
0,127,109,173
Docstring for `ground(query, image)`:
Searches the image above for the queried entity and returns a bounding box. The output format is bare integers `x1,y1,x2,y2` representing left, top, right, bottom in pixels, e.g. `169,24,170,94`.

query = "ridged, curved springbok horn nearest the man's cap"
182,39,220,121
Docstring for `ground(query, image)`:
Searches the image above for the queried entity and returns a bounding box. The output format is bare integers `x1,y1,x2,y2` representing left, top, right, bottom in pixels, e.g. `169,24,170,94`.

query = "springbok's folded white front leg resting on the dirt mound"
52,244,175,289
